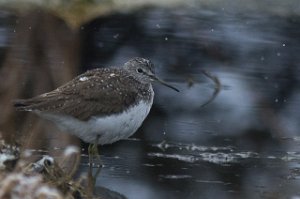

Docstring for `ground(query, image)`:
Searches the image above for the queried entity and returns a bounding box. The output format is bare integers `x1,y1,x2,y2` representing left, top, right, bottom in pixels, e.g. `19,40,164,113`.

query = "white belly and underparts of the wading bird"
38,90,153,145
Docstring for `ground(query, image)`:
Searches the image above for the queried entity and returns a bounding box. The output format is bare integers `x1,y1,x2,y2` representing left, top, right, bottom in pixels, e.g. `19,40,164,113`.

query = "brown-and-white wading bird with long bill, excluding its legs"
14,57,179,148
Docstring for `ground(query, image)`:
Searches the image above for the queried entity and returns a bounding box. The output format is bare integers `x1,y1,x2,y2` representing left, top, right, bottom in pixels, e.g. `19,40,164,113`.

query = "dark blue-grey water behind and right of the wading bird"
0,4,300,199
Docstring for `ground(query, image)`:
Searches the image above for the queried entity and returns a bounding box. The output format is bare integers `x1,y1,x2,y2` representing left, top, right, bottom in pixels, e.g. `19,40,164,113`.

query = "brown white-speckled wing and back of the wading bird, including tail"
15,68,144,120
